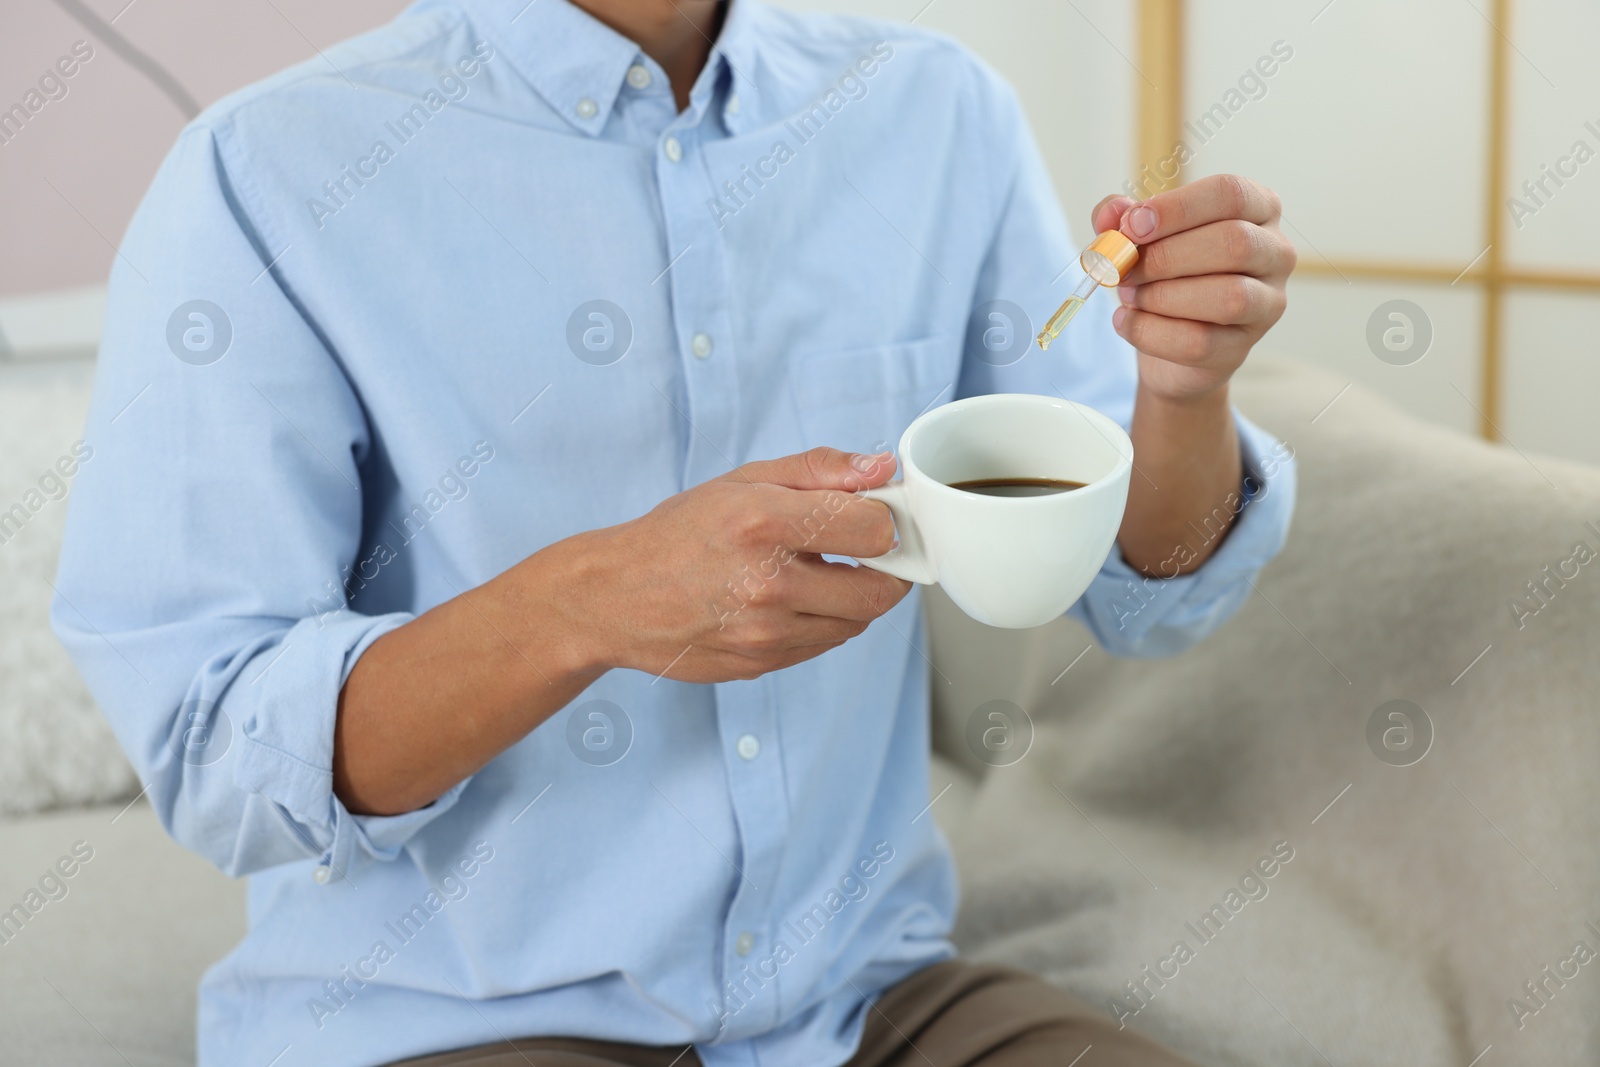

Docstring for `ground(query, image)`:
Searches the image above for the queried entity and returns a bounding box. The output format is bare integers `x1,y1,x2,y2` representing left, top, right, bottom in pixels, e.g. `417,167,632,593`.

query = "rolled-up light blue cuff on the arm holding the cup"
234,611,470,881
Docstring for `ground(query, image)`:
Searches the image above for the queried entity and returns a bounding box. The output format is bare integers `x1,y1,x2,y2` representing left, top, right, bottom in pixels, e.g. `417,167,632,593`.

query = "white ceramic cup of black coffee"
861,394,1133,629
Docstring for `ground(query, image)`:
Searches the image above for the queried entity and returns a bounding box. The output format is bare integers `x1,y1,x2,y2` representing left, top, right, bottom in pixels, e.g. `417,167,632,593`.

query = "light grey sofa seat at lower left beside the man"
0,800,243,1067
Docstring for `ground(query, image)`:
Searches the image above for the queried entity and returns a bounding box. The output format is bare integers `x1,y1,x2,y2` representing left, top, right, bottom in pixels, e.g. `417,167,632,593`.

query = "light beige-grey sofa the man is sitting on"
0,358,1600,1067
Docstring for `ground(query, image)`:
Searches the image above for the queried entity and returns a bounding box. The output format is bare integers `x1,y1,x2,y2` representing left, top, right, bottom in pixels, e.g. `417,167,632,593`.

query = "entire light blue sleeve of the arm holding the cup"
51,125,461,877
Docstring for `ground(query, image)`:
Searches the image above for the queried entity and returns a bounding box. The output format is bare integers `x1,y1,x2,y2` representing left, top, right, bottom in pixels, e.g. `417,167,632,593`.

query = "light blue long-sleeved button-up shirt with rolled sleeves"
54,0,1293,1067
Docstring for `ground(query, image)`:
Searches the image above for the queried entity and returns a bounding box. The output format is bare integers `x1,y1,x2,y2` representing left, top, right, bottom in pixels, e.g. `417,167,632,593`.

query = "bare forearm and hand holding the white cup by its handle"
333,448,910,814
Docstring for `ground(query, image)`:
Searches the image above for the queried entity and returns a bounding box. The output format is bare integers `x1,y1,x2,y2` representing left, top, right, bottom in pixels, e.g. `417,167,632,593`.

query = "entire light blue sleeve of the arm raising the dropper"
957,64,1294,656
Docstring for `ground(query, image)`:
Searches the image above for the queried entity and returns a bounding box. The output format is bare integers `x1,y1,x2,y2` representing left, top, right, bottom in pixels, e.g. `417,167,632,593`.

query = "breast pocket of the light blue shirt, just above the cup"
789,338,960,453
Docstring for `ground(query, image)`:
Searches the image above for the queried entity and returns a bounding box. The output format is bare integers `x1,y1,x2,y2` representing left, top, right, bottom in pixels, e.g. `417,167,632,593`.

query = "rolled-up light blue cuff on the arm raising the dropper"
1069,413,1296,657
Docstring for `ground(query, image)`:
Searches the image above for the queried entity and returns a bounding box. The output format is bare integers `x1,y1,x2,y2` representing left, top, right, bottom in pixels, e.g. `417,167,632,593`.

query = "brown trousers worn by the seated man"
392,960,1194,1067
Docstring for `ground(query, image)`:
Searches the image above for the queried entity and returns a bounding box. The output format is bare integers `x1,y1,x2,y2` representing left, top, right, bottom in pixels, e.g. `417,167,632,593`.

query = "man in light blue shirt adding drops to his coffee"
54,0,1294,1067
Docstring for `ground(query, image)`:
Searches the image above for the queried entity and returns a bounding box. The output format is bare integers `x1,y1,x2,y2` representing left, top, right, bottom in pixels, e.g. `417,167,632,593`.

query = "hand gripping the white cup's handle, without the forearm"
560,448,910,681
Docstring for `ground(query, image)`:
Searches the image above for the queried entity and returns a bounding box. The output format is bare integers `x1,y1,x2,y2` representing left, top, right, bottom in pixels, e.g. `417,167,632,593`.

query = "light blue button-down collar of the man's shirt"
459,0,755,136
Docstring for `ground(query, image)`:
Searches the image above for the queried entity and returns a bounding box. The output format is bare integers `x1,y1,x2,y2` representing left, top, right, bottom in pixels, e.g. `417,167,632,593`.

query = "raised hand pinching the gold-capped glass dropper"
1094,174,1296,402
